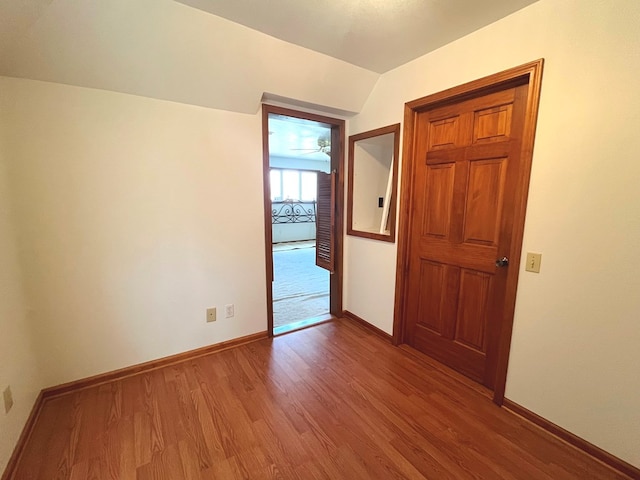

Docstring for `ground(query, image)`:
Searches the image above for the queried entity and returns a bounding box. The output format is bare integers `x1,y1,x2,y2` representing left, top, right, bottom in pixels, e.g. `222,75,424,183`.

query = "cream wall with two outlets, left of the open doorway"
0,78,267,386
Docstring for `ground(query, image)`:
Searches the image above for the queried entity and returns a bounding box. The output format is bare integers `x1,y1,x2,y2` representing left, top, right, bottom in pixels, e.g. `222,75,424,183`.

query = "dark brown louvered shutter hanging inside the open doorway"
316,172,336,273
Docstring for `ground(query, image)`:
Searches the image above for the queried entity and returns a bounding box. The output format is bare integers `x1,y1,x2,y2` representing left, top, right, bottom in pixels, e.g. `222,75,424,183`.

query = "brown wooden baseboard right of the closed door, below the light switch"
502,398,640,479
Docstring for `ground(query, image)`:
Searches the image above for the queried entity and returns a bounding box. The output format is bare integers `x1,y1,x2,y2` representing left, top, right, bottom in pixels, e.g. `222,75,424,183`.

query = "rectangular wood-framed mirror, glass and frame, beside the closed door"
347,123,400,242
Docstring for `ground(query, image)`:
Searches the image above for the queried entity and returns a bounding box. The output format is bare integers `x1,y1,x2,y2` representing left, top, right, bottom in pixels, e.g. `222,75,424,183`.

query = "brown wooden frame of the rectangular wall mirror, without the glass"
347,123,400,243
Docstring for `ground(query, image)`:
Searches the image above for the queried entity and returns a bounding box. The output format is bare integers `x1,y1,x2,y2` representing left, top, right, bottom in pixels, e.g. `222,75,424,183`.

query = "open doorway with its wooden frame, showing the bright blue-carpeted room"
263,105,344,335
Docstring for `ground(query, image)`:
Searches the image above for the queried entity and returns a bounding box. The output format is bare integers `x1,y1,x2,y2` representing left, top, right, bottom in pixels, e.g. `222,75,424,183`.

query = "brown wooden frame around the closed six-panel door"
393,59,544,405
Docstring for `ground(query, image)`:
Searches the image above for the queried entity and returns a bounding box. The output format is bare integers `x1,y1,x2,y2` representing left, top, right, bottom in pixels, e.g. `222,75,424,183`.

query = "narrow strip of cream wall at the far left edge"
0,107,43,472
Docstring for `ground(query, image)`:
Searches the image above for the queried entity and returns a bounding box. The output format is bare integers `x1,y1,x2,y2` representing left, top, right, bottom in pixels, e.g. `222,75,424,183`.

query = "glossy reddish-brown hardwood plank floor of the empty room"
7,320,626,480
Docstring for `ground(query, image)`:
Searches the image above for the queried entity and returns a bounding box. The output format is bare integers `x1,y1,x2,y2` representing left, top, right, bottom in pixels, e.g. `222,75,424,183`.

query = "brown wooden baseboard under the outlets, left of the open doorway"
42,331,269,400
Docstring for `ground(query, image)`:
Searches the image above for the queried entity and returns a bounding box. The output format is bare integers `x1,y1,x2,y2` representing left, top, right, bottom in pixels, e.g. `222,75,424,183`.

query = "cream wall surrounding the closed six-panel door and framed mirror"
345,0,640,466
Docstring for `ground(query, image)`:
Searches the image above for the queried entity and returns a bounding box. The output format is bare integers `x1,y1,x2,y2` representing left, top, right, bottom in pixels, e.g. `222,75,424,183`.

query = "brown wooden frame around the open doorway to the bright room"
262,103,345,337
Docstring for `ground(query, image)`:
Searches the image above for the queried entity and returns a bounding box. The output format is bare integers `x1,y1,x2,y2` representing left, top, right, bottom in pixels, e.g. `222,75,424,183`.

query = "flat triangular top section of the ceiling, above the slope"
176,0,537,73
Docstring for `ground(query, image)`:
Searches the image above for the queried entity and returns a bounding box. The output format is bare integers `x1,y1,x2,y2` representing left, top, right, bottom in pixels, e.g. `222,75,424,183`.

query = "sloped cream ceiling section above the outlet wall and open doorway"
0,0,378,114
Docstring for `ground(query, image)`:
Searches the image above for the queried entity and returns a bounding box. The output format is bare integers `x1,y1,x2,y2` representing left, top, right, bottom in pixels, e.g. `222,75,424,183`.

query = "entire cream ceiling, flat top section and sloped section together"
0,0,536,115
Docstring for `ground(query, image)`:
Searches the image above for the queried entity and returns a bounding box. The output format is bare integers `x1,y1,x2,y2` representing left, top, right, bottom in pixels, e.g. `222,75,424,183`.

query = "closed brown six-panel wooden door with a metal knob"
404,84,528,388
